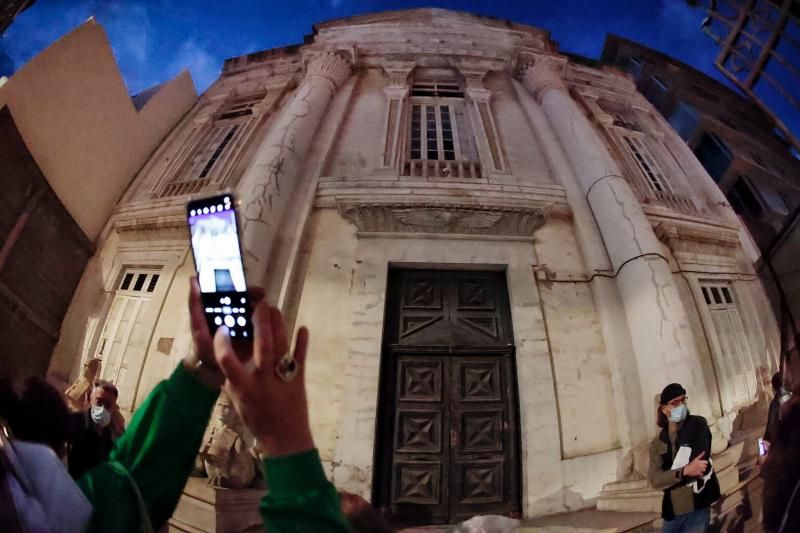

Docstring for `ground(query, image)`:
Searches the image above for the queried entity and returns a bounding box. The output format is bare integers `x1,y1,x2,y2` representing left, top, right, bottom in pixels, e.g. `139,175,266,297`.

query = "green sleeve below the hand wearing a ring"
261,450,350,533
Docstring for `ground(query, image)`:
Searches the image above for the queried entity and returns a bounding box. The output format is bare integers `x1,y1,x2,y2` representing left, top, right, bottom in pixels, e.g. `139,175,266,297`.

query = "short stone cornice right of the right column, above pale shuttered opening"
655,222,741,257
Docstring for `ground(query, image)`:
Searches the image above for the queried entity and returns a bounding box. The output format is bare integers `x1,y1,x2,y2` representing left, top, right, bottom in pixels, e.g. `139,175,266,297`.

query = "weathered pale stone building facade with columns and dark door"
53,9,777,523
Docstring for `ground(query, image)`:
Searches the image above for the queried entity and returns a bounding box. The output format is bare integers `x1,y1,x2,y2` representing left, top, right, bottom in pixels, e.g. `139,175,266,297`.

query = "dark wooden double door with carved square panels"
373,270,520,525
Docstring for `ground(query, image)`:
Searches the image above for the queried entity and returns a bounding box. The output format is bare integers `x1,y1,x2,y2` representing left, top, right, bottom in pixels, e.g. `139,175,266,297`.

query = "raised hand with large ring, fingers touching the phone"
214,301,314,457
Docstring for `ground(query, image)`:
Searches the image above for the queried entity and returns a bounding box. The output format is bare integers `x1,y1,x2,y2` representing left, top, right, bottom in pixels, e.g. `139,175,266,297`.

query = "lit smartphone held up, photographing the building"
187,194,253,340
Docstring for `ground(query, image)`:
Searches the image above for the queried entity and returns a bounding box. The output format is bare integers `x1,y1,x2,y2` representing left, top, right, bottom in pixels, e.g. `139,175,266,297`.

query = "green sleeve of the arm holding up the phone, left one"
78,364,218,531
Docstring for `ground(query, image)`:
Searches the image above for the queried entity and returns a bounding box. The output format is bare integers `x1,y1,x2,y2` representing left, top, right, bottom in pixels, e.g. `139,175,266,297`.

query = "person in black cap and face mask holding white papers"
648,383,720,533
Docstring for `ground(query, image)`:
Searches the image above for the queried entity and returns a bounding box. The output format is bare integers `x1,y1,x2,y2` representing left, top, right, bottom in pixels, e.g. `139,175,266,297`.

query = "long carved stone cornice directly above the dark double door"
337,201,550,237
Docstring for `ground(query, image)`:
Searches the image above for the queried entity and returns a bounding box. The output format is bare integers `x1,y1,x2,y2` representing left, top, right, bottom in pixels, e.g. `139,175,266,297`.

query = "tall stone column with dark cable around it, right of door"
522,56,711,434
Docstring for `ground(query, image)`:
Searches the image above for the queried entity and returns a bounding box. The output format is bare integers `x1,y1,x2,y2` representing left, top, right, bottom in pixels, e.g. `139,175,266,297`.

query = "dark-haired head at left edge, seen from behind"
0,376,69,457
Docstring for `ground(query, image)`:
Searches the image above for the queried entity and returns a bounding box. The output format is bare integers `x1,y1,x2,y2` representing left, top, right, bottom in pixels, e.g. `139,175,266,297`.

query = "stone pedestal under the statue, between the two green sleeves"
167,478,265,533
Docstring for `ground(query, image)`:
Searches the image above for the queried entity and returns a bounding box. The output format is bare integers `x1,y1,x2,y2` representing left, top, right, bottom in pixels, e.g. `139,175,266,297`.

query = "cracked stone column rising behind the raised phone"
237,51,352,285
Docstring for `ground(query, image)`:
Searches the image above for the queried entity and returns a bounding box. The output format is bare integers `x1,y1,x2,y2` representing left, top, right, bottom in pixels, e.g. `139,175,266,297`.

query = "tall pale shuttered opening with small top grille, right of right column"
700,282,759,409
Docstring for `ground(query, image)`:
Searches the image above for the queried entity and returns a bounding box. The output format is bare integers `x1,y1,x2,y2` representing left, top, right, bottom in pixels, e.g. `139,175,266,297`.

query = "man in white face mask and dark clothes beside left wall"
68,381,124,479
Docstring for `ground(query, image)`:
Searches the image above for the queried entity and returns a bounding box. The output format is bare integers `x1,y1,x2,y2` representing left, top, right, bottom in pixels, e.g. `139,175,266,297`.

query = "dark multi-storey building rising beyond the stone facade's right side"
601,35,800,254
